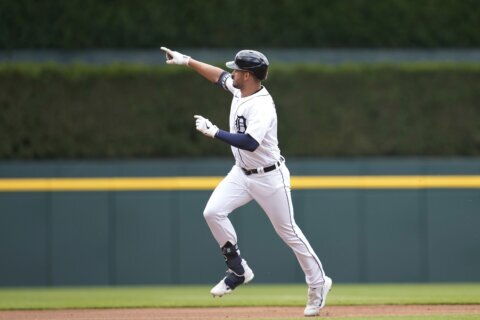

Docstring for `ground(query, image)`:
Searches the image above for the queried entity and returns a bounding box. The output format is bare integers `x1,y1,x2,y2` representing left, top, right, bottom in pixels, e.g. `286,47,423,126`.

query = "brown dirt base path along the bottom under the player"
0,305,480,320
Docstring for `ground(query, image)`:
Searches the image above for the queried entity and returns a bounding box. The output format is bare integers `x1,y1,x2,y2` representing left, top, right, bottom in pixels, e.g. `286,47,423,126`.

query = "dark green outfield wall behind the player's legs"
0,159,480,286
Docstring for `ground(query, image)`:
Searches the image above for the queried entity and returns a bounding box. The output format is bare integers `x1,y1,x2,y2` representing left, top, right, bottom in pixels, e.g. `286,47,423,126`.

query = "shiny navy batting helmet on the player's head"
226,50,268,80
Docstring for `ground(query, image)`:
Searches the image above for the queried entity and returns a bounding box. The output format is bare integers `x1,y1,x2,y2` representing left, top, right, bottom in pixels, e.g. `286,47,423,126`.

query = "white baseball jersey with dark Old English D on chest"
223,77,280,169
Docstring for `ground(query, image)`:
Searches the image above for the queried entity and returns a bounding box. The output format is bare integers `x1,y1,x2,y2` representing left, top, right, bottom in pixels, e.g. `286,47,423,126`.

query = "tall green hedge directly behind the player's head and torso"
0,64,480,159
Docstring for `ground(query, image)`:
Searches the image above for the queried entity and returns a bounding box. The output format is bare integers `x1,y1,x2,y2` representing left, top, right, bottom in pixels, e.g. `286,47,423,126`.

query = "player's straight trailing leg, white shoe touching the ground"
251,165,331,316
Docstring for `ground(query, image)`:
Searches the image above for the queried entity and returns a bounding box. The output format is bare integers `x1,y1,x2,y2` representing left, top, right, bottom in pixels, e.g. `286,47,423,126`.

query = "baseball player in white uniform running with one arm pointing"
161,47,332,316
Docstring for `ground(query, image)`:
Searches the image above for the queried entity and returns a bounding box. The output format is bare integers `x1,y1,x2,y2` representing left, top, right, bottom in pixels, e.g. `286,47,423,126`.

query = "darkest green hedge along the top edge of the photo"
0,0,480,49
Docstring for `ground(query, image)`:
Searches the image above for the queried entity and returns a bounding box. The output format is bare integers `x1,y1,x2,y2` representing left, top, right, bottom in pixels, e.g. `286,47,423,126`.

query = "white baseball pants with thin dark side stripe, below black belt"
203,163,325,287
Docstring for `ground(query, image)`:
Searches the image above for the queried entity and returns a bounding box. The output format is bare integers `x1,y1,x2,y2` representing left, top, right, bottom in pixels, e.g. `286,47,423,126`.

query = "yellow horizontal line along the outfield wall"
0,175,480,192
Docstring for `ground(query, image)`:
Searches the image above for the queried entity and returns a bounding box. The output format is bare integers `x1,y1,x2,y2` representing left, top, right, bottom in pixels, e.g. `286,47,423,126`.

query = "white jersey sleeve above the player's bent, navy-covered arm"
245,99,276,144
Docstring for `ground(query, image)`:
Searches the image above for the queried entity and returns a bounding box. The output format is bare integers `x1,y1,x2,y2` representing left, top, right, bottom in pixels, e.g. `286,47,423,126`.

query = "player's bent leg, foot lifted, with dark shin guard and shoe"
203,167,253,296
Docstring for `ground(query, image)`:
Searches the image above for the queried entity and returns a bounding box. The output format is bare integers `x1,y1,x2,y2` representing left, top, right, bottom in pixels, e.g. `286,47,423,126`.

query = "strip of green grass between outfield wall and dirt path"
0,283,480,320
